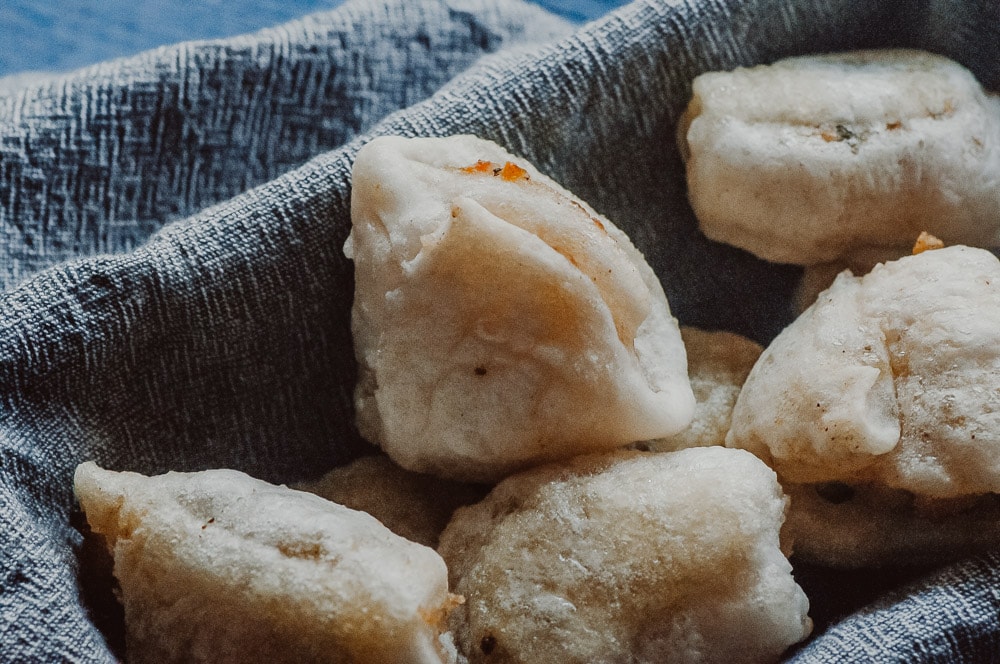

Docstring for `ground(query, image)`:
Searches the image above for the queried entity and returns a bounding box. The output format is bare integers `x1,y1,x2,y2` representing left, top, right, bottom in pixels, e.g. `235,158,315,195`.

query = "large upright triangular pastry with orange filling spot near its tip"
345,136,694,482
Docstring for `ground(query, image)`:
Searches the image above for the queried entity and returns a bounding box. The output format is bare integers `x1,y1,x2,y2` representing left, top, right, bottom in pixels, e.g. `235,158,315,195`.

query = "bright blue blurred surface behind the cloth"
0,0,626,76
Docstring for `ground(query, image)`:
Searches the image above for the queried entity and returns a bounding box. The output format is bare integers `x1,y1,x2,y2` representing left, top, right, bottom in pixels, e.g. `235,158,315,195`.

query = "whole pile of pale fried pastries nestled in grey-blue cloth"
76,51,1000,663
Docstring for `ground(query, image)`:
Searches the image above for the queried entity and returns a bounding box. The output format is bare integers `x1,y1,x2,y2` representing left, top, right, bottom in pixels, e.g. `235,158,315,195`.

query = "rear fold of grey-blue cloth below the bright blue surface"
0,0,571,289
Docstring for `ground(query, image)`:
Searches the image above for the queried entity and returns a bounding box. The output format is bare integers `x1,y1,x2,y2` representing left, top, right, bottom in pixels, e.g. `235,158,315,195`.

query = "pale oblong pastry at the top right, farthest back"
678,50,1000,265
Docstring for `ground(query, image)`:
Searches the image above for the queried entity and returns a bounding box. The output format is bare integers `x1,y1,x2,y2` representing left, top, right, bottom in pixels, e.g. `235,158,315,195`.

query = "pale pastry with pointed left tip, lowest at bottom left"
75,462,456,664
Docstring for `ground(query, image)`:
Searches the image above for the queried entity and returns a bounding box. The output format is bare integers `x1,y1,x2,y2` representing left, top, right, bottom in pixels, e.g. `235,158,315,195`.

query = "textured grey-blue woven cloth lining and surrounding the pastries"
0,0,1000,663
